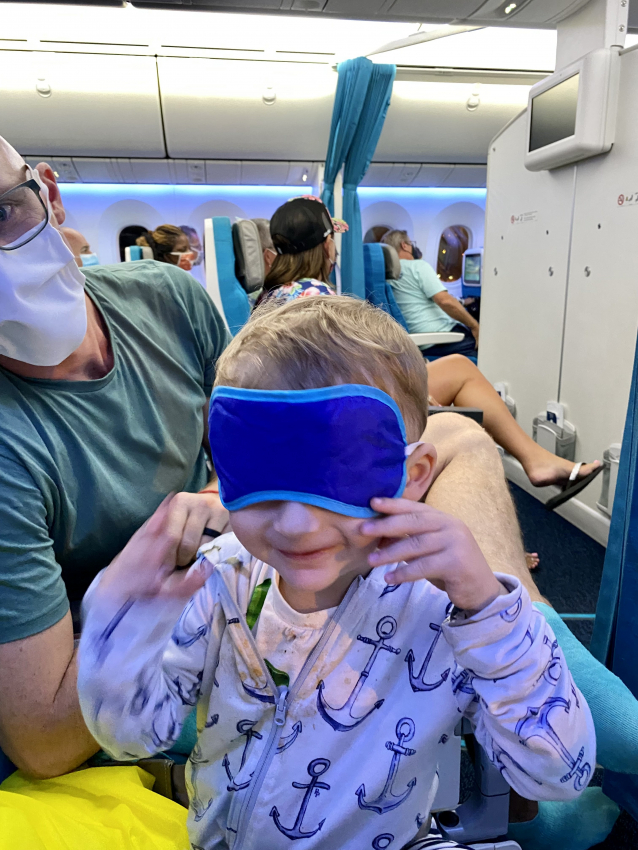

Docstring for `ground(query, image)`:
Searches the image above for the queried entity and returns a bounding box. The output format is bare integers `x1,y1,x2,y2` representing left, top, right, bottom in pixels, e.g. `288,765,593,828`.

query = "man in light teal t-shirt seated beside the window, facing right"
381,230,479,357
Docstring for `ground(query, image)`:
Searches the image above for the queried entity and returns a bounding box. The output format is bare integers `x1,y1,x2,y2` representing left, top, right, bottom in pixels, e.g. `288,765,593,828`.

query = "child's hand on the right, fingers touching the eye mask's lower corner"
361,499,507,612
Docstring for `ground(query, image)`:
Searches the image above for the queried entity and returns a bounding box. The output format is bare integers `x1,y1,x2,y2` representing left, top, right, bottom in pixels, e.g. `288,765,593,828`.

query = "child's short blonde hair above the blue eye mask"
215,295,428,442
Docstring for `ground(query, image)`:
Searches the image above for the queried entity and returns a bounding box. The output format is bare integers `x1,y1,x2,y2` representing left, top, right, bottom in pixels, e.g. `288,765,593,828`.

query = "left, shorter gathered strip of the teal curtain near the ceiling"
321,56,372,215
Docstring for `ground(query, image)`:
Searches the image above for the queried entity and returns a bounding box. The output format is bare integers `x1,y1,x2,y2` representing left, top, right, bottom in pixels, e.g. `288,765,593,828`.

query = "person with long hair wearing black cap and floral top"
257,195,348,306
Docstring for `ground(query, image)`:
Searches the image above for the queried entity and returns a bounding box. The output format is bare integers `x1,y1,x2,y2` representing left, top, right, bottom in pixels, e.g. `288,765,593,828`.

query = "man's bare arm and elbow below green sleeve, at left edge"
0,613,99,779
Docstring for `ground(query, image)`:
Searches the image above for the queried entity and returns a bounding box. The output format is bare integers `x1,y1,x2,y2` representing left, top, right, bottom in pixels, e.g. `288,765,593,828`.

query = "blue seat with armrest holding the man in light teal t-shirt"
363,242,463,352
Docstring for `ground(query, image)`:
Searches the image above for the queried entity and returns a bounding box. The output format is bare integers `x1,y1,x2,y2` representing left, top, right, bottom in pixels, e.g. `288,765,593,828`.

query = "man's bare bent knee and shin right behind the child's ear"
423,413,547,602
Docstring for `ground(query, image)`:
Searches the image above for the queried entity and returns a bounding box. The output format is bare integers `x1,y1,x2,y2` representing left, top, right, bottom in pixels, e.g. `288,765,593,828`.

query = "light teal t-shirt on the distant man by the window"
391,260,457,348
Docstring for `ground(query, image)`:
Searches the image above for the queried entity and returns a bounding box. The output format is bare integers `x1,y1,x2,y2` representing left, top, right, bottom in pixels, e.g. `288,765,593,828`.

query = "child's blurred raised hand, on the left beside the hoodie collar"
100,495,216,602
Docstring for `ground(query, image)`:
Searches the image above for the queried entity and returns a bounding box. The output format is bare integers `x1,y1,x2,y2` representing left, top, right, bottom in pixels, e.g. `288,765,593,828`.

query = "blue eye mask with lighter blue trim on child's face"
209,384,407,518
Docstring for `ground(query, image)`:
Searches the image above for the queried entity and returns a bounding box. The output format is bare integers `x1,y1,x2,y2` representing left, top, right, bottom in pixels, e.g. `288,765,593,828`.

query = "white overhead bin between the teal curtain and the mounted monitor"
375,80,529,163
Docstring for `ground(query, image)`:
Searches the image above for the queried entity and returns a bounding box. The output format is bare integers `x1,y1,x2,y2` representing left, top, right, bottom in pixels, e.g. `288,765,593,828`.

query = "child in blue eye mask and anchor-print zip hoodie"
78,296,596,850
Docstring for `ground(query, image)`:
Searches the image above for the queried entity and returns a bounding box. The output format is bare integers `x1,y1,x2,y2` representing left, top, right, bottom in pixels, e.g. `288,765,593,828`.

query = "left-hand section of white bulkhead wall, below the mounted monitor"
474,115,575,436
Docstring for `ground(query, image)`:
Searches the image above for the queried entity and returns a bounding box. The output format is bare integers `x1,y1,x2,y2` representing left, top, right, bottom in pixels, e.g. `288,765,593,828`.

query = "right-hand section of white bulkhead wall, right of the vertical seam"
560,44,638,508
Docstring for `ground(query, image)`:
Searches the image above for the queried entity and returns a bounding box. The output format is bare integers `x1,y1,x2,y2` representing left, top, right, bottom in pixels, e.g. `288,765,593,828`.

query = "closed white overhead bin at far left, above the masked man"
0,50,166,157
